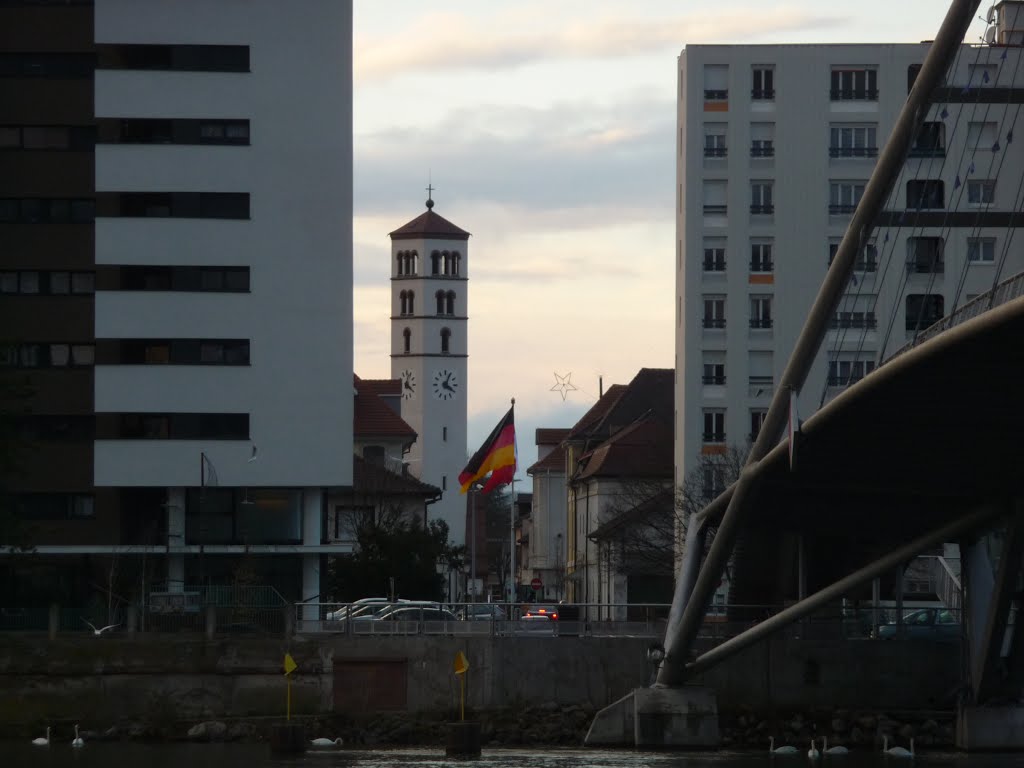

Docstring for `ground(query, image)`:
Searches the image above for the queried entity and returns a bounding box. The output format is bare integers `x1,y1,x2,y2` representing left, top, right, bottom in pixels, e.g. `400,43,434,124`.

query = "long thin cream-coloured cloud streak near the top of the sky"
354,5,847,83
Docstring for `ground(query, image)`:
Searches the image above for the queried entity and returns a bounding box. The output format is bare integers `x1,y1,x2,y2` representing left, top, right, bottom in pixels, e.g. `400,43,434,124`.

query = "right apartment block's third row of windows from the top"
702,179,995,216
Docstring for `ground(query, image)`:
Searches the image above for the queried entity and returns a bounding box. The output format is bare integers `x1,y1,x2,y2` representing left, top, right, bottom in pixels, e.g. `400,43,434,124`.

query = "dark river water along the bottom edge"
0,742,1024,768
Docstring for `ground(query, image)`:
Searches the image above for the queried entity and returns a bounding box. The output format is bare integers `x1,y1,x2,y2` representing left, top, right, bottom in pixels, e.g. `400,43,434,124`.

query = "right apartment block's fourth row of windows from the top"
701,237,995,273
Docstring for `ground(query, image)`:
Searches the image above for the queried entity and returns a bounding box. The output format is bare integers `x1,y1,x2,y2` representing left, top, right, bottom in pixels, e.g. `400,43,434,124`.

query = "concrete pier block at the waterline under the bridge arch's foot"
584,685,721,750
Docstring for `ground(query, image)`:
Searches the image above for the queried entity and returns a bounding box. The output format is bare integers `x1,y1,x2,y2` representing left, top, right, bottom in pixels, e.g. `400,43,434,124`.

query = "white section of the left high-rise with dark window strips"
94,0,353,614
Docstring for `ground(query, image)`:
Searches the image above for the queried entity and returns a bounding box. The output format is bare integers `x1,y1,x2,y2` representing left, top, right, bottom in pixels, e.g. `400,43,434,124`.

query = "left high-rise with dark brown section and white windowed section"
0,0,353,614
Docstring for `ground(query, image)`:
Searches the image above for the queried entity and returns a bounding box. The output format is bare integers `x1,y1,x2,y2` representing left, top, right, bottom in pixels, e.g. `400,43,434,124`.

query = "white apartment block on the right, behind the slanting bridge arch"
675,28,1024,528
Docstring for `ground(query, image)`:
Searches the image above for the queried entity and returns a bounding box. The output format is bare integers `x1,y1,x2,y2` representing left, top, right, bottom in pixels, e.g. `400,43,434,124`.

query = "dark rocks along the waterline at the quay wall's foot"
4,703,953,752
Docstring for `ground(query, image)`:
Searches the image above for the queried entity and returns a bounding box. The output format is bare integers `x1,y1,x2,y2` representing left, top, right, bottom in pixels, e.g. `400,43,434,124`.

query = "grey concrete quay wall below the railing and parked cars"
0,634,959,727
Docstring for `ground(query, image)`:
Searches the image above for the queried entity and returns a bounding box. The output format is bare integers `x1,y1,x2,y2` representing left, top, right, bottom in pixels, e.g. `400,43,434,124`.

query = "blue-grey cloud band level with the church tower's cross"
354,93,676,219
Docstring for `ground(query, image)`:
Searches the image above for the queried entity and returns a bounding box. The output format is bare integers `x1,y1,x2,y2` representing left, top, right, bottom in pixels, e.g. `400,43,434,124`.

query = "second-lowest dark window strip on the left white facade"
96,339,249,366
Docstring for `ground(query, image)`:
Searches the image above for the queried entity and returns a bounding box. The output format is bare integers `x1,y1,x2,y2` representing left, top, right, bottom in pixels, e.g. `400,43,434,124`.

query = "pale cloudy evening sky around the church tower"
353,0,987,475
